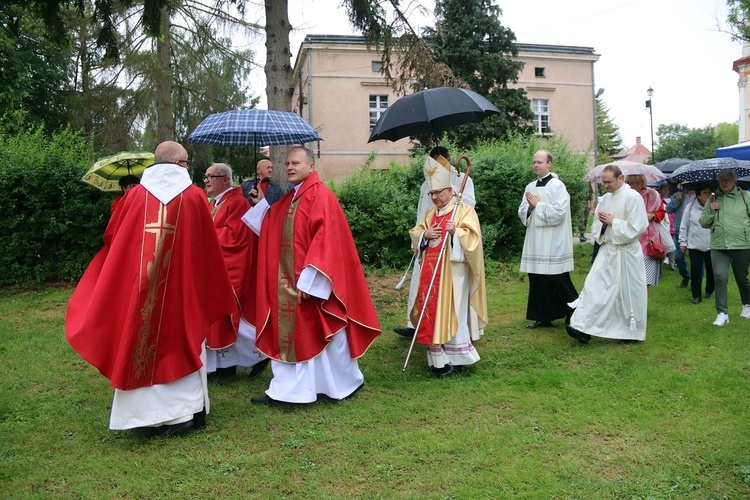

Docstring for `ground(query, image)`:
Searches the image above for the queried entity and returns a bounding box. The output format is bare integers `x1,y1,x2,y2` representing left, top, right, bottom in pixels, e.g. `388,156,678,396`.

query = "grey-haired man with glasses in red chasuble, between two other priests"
203,163,268,378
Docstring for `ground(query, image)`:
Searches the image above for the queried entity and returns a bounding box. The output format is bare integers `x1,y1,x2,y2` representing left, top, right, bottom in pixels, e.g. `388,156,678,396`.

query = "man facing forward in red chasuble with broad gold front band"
243,147,380,404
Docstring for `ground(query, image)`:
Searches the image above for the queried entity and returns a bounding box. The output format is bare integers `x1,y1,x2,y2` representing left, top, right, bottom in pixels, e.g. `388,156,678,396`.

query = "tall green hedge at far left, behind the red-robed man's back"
0,129,113,285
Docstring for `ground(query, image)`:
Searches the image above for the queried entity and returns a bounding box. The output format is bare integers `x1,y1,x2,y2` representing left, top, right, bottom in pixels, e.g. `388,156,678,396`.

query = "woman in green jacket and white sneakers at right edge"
700,168,750,326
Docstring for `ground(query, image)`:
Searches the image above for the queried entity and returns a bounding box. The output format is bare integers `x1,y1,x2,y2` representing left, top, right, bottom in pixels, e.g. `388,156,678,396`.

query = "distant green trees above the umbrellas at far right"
655,123,739,162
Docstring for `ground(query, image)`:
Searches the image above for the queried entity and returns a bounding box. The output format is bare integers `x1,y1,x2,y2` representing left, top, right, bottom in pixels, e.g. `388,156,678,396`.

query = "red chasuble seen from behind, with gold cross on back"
70,185,235,390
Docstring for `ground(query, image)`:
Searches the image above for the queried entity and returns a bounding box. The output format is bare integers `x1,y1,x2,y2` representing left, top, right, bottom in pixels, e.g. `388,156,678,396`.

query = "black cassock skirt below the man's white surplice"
526,273,578,324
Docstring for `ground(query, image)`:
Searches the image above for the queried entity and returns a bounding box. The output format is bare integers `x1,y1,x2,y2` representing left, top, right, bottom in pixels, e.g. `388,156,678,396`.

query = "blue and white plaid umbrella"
188,109,323,147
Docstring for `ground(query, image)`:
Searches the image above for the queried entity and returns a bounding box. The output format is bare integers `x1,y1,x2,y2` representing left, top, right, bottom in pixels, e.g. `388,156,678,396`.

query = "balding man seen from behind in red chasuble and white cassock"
65,141,234,436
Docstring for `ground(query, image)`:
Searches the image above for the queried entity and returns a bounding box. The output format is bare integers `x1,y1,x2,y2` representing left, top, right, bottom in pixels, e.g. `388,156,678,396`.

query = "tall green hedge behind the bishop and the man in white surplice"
333,136,588,268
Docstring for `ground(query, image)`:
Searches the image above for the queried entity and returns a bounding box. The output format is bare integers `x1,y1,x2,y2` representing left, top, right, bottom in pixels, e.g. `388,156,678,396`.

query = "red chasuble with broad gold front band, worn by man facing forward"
255,172,380,363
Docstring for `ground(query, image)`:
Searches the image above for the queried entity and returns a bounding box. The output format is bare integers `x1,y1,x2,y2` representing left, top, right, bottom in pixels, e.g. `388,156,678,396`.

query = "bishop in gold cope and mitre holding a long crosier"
409,157,487,377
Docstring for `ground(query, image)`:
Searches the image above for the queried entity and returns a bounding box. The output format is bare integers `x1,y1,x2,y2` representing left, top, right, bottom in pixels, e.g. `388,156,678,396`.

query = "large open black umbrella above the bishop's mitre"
367,87,500,142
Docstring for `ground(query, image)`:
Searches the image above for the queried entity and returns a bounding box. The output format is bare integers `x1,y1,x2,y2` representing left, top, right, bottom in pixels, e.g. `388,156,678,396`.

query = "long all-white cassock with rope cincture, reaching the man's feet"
570,184,648,341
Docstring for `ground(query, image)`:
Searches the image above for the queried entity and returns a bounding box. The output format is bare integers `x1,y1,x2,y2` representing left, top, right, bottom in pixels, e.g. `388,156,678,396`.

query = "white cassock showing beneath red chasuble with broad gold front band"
242,191,365,403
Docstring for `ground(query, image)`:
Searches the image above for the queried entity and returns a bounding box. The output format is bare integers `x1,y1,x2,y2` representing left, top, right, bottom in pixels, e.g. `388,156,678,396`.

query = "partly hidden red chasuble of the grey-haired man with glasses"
207,187,258,349
